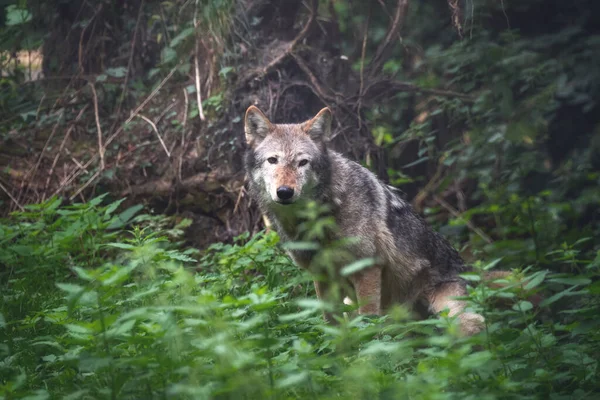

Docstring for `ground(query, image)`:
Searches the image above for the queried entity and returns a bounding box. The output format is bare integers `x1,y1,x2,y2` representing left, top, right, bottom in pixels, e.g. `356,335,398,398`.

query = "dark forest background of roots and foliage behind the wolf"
0,0,600,250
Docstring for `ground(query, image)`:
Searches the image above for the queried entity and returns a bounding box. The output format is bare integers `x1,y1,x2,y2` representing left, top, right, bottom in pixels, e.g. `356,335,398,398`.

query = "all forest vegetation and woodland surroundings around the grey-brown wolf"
0,0,600,399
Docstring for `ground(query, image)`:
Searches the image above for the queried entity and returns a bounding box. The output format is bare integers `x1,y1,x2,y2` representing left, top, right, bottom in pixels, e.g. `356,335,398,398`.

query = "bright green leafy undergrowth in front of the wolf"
0,198,600,399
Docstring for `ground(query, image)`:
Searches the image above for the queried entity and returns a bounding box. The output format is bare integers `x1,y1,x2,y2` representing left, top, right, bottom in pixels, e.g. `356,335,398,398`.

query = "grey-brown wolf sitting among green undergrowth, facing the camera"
244,106,484,335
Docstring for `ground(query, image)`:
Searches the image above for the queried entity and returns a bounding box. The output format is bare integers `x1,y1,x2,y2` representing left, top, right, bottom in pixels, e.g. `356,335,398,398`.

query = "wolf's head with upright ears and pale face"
244,106,331,204
